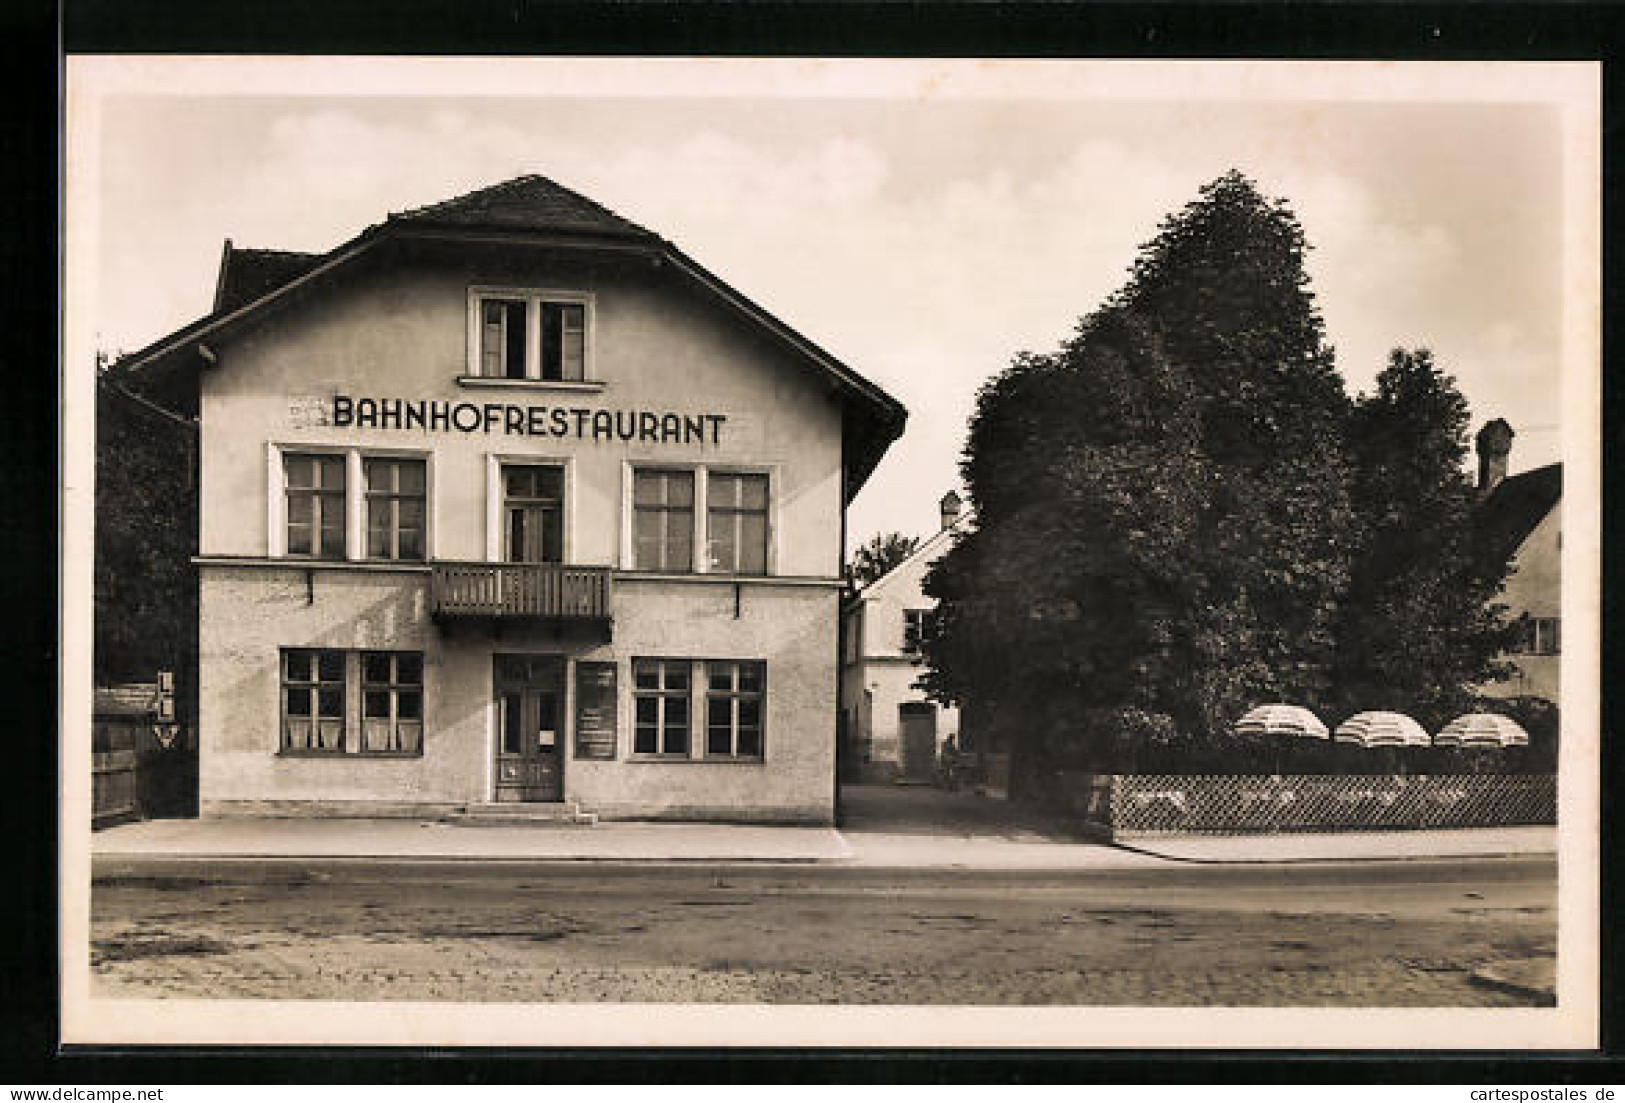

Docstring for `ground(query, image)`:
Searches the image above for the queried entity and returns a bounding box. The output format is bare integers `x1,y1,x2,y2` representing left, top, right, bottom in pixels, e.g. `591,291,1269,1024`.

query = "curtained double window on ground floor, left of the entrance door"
281,648,423,755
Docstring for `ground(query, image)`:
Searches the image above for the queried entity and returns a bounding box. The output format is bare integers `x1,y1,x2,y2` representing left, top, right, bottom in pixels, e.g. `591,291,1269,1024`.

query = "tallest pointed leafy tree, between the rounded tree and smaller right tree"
1118,172,1352,714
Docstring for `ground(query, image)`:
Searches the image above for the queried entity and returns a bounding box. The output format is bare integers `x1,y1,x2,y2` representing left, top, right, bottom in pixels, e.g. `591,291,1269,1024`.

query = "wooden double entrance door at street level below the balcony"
496,655,564,802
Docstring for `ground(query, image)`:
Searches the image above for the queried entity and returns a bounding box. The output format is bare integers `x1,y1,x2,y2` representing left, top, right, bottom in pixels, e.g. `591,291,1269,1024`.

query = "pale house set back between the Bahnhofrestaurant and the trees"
840,491,964,781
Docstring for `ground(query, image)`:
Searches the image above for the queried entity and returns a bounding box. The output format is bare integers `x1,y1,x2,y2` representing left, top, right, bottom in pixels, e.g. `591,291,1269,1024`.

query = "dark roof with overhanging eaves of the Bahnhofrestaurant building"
114,175,908,500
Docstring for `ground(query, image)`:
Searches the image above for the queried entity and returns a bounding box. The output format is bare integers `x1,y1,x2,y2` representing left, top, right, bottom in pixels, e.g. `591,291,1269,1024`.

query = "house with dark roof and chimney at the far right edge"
1477,417,1563,703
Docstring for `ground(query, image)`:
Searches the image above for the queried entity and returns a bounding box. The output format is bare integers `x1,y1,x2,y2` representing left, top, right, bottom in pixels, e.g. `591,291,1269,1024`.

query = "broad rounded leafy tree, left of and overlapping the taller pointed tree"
925,309,1207,757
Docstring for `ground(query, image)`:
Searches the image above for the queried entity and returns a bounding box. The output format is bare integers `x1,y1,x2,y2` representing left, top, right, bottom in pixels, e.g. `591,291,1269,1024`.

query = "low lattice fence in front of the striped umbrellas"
1089,775,1557,837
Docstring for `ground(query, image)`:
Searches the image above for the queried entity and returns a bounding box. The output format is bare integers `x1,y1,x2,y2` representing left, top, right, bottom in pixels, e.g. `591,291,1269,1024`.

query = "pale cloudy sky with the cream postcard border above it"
67,58,1576,546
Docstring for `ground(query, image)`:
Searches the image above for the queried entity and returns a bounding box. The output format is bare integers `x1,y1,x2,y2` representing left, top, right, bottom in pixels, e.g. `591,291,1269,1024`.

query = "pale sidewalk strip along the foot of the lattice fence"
1120,827,1557,863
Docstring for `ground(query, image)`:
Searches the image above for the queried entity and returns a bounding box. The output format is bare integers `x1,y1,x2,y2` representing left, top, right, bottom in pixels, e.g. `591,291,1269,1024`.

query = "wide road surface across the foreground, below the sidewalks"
91,856,1557,1007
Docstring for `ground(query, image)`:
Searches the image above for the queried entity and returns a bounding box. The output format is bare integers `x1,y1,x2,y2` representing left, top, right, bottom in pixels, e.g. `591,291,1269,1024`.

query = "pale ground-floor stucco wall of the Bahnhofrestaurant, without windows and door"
200,565,837,822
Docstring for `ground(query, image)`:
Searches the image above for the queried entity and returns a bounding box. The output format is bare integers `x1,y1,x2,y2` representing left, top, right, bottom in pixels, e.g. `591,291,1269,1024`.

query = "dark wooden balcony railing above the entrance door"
429,562,611,621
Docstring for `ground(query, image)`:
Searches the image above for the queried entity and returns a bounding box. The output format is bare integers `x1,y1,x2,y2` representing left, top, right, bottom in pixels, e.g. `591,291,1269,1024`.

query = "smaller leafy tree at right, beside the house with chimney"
1336,349,1511,729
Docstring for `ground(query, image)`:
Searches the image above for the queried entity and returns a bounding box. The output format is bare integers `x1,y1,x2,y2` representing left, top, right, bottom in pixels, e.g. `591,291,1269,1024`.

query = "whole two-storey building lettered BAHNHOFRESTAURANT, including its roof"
115,175,905,822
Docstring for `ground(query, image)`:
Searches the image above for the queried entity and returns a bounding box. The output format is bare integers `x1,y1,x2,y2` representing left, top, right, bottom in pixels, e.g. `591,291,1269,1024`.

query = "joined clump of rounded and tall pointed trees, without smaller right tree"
926,172,1352,776
